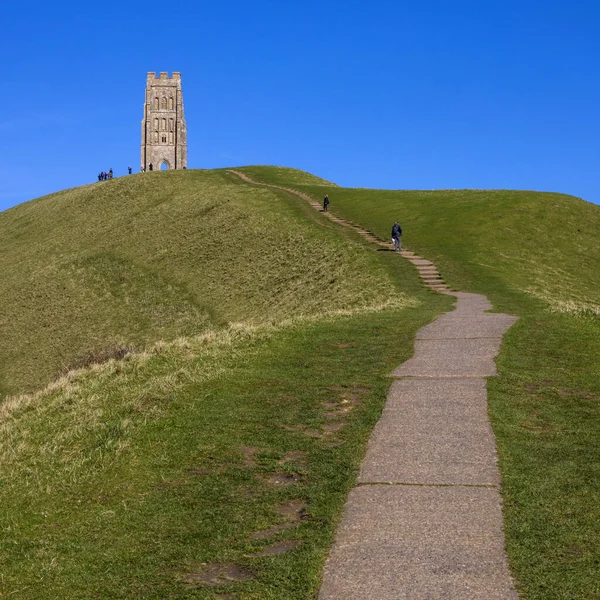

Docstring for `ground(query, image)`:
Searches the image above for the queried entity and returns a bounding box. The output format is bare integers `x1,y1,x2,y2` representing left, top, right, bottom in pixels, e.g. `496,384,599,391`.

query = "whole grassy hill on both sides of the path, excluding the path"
0,167,600,600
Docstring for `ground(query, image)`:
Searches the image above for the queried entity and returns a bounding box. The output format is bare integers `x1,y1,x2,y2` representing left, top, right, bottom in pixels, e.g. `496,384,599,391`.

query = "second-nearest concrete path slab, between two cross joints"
358,378,500,485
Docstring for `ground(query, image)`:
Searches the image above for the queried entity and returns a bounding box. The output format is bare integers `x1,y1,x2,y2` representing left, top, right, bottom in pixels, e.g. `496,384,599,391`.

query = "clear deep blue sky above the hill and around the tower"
0,0,600,209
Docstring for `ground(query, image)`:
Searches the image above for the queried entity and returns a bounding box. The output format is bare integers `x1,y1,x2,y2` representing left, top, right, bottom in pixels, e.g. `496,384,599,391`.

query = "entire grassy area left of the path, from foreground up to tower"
0,171,450,600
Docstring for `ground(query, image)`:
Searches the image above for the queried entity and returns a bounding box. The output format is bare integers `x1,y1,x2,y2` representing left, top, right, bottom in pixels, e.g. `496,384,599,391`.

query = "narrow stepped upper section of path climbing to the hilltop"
227,169,450,293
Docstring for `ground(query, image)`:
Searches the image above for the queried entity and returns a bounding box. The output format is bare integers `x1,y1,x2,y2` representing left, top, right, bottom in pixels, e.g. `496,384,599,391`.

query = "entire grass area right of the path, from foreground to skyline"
239,169,600,600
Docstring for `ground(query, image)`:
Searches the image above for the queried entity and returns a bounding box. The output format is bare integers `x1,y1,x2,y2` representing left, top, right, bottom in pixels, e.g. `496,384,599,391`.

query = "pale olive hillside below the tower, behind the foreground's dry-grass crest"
0,171,385,393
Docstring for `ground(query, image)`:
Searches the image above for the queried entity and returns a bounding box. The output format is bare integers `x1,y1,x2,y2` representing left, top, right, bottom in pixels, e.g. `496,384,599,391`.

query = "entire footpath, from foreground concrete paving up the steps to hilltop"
229,170,518,600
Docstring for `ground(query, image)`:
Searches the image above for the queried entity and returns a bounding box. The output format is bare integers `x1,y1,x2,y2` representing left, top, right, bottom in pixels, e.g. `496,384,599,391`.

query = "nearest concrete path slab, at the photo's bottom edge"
319,485,518,600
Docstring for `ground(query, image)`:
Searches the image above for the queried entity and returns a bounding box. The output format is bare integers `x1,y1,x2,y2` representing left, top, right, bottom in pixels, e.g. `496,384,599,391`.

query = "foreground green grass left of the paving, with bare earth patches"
0,298,446,600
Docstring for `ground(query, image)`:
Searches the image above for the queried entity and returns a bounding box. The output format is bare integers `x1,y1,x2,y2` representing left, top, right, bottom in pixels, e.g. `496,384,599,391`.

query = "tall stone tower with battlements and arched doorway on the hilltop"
142,72,187,171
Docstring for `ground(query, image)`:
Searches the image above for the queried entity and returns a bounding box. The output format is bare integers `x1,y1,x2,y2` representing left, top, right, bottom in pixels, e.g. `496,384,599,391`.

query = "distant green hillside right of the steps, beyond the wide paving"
238,167,600,314
